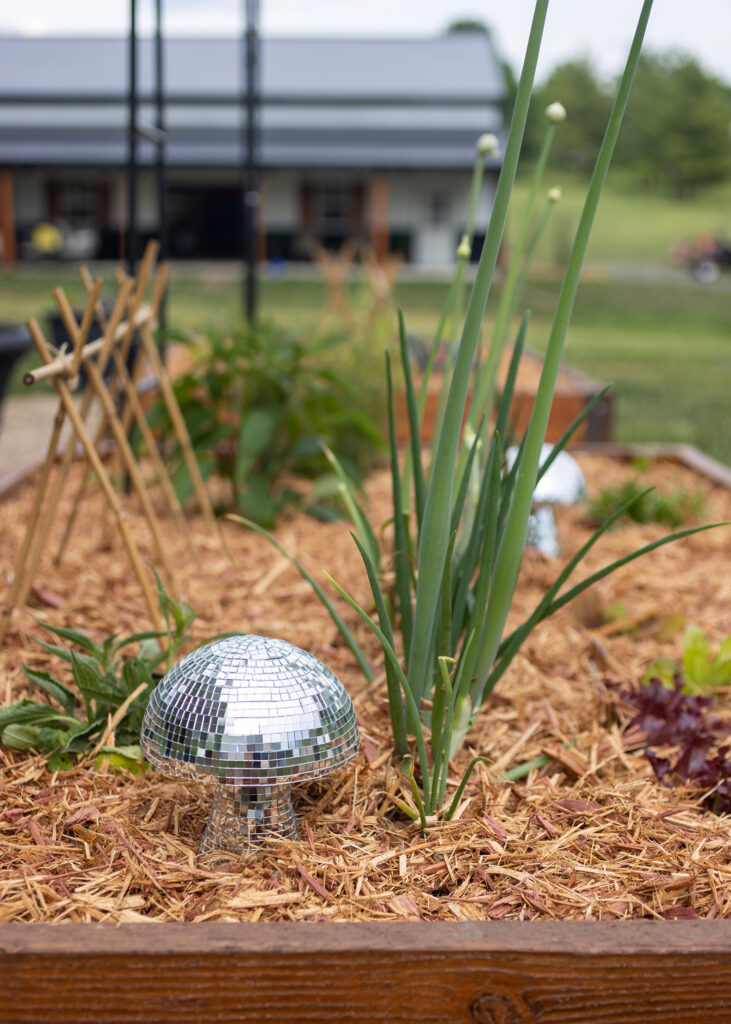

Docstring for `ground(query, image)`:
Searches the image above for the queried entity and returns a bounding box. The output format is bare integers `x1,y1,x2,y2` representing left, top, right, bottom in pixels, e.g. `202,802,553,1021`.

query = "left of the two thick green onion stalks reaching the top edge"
409,0,548,699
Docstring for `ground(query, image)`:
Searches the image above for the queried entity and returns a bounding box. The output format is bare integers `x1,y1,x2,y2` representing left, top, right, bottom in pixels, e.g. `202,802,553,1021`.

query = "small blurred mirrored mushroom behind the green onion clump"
505,444,587,558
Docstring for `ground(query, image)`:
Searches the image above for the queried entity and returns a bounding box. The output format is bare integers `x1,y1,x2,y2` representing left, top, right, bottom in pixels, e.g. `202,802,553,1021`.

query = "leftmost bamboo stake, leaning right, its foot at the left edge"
0,284,101,655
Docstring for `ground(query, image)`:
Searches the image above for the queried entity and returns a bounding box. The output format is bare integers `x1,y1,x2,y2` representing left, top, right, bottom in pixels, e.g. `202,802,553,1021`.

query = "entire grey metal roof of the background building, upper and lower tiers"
0,34,505,169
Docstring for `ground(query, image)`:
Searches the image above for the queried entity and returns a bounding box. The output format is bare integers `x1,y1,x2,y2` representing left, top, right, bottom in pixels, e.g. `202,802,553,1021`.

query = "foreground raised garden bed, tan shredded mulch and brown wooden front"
0,453,731,1022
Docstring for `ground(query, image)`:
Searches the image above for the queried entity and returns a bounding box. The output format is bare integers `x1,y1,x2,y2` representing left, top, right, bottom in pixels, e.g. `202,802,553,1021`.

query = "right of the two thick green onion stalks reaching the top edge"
472,0,652,707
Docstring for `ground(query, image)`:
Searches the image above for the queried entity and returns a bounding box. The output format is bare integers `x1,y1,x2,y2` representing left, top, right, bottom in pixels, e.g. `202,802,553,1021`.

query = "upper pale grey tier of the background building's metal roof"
0,33,505,102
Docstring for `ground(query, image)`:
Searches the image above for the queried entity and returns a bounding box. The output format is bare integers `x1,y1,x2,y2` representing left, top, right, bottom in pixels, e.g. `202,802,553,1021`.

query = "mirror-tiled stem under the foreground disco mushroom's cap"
201,785,297,854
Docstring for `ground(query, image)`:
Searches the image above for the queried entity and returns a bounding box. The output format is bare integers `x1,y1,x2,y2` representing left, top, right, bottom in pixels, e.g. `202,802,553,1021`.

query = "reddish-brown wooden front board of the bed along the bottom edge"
0,922,731,1024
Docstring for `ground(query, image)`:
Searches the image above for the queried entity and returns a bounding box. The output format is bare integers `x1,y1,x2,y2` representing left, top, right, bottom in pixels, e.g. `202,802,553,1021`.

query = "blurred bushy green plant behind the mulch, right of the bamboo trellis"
157,323,382,526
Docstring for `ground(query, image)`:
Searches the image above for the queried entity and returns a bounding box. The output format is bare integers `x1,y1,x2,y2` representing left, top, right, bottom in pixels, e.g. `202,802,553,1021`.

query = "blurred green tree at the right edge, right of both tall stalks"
616,53,731,198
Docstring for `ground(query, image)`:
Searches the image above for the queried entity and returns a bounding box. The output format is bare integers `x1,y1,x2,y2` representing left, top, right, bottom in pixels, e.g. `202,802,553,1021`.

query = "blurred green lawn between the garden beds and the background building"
0,179,731,463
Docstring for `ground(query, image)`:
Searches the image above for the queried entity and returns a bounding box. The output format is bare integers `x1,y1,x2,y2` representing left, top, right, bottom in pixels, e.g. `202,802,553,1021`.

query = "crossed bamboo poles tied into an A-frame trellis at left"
0,242,218,659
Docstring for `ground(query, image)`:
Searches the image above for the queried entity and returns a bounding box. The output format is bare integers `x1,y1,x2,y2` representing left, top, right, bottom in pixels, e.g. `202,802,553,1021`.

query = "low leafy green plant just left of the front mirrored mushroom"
0,573,196,771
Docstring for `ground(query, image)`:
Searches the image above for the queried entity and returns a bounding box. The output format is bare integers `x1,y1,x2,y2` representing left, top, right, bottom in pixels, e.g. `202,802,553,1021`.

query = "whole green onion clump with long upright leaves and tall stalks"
234,0,724,826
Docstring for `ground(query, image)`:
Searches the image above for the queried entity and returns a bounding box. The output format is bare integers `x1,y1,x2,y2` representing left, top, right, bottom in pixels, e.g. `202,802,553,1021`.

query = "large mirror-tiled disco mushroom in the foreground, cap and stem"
140,634,358,854
